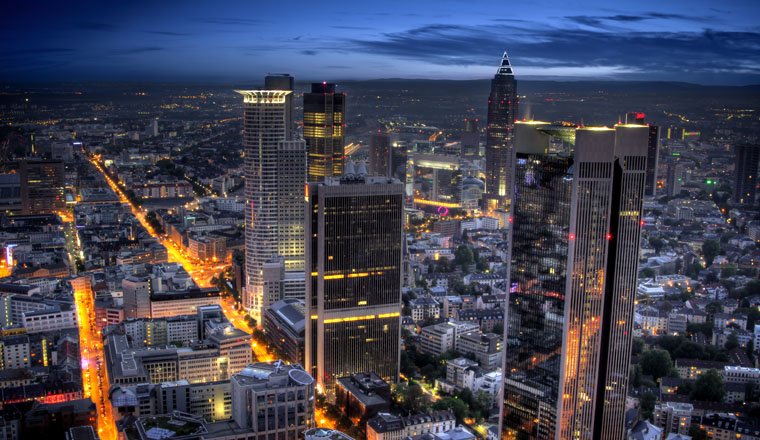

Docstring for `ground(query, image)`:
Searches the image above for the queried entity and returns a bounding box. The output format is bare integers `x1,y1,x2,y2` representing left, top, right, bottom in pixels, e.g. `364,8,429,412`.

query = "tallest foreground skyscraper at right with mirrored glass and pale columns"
502,122,648,439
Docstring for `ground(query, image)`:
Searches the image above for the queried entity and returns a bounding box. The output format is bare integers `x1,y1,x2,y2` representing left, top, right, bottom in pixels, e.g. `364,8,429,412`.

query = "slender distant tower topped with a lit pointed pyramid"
483,52,517,212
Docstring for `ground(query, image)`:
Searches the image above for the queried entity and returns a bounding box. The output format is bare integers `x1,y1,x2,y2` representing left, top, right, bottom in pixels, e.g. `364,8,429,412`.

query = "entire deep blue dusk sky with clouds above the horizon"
0,0,760,84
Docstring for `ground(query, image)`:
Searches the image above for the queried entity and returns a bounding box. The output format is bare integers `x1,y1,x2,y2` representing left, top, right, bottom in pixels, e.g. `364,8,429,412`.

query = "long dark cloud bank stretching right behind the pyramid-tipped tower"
346,22,760,81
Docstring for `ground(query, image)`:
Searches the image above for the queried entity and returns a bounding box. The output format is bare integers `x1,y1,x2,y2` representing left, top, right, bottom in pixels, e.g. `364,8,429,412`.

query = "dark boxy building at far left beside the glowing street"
19,159,66,214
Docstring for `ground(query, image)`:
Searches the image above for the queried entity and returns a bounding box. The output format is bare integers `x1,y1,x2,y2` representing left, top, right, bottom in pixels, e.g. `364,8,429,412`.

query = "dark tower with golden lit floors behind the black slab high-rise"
303,82,346,182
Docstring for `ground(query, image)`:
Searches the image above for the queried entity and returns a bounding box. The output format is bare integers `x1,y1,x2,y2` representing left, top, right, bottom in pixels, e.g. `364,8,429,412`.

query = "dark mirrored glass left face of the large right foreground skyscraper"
502,154,573,439
